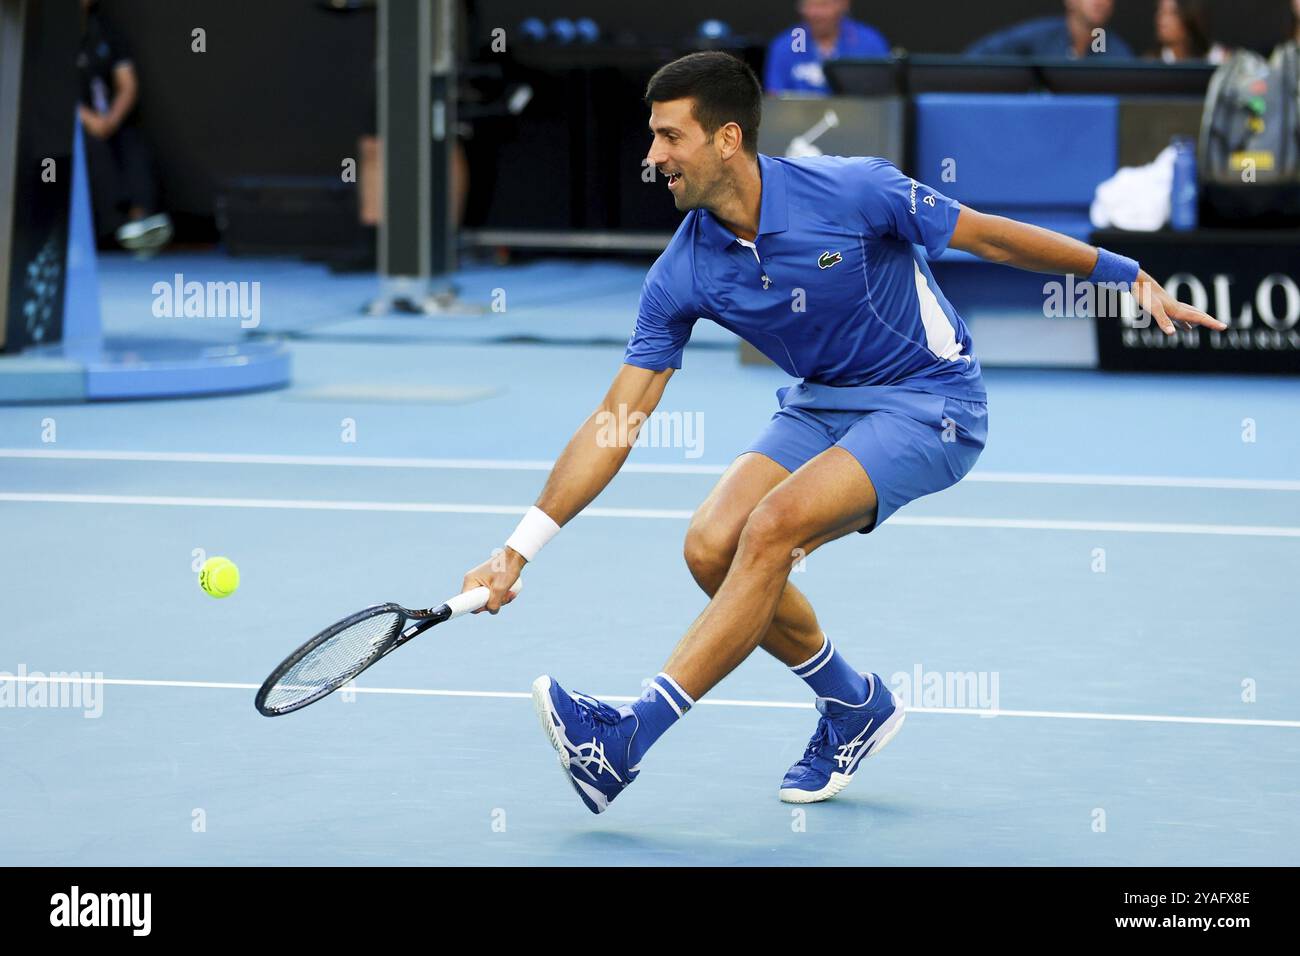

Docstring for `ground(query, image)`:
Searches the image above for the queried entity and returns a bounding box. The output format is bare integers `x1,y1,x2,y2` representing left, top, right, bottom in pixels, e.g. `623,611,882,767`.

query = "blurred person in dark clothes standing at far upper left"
77,0,172,254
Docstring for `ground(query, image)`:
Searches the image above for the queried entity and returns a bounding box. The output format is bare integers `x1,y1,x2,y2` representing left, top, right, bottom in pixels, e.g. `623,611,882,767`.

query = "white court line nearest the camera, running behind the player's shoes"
0,671,1300,730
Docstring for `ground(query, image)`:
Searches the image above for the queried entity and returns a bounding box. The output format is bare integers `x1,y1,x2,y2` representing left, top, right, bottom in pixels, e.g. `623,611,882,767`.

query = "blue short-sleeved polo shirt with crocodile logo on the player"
624,155,985,401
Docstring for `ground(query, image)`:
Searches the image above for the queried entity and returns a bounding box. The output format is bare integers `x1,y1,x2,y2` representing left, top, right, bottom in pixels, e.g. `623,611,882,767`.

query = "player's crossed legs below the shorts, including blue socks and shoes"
533,447,904,813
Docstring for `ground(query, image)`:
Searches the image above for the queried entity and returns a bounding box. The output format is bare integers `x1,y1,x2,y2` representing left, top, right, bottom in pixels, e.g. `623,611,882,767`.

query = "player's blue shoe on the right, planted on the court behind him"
780,674,905,804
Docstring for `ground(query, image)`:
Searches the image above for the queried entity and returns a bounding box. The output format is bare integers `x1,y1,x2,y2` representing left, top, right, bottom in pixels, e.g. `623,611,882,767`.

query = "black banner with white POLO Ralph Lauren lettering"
1092,230,1300,375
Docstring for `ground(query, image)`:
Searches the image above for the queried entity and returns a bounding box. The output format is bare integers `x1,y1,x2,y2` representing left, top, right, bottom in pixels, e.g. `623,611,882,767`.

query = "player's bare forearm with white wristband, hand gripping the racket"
462,364,673,614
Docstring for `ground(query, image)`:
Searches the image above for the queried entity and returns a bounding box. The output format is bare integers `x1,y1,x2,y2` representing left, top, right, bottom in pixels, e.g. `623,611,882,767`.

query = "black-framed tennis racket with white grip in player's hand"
254,581,523,717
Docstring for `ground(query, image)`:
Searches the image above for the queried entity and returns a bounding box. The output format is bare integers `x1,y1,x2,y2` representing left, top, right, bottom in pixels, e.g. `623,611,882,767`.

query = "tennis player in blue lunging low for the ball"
464,52,1225,813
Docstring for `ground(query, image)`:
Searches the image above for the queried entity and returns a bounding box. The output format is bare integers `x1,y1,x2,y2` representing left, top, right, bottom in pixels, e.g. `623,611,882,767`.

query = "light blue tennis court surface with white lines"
0,255,1300,866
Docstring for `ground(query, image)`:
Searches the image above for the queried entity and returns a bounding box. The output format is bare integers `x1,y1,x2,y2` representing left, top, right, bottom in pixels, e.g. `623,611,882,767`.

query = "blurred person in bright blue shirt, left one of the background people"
763,0,889,94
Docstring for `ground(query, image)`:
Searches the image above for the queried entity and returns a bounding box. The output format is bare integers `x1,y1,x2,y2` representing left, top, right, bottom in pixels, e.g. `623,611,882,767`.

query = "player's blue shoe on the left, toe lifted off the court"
533,674,641,813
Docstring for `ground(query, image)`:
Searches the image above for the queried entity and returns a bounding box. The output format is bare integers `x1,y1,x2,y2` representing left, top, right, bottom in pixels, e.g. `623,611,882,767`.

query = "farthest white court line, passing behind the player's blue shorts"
0,449,1300,492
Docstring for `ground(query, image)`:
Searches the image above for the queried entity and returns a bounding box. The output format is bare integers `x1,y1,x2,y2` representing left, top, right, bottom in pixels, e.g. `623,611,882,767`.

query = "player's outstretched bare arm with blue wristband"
949,206,1227,336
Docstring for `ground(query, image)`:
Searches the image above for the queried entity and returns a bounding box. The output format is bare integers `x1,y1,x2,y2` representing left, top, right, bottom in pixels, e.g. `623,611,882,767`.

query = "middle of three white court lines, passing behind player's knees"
0,492,1300,537
